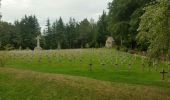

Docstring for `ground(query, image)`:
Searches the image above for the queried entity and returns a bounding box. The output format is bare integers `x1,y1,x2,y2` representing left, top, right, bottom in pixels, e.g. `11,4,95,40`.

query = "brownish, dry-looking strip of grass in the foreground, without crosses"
0,68,170,100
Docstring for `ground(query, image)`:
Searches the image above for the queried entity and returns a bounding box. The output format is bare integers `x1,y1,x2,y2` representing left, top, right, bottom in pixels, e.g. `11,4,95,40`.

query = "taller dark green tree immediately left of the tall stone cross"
20,15,41,49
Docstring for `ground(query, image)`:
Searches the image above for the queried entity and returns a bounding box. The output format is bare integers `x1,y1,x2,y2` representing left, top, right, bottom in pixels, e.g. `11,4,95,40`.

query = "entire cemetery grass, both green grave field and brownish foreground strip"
0,49,170,100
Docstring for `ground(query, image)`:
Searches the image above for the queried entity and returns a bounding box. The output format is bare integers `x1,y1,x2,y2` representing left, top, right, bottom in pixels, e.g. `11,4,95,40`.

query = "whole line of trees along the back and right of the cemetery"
0,0,170,57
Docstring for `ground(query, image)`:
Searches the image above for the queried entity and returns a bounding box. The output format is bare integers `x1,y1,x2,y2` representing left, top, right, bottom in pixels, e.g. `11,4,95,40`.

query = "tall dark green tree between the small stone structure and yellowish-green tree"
108,0,150,48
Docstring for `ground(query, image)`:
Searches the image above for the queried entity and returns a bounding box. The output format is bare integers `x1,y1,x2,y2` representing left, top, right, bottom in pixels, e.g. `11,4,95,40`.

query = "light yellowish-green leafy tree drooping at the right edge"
137,0,170,58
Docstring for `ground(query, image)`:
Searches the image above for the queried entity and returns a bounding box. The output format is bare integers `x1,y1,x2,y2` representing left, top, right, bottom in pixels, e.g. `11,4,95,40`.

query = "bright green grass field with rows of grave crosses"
2,49,170,88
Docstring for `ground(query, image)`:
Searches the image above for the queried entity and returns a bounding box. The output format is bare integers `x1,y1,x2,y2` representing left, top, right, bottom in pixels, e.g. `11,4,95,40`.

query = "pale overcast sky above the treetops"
0,0,112,27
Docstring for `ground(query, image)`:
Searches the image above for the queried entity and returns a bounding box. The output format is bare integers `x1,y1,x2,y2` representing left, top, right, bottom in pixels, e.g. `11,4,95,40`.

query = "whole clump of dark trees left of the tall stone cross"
0,15,41,49
